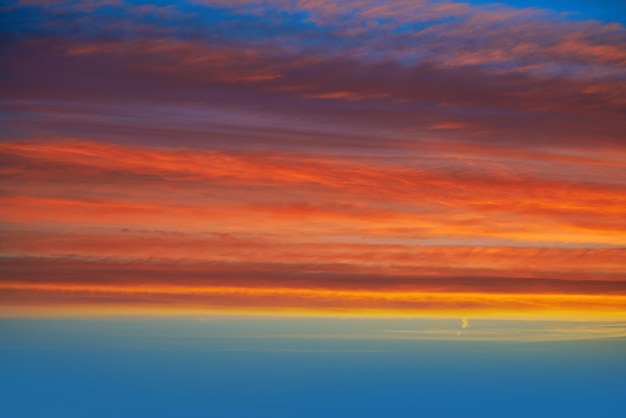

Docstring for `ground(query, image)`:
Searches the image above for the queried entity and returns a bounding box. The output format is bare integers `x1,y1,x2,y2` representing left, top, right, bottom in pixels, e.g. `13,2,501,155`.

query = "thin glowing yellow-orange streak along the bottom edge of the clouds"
0,283,626,320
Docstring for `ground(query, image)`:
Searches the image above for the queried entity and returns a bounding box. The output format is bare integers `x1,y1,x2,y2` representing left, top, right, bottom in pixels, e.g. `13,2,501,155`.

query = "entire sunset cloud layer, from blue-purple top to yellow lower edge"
0,0,626,320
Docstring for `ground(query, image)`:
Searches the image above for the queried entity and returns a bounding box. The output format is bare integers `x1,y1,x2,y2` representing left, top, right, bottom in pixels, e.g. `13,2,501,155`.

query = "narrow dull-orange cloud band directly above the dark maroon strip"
0,230,626,282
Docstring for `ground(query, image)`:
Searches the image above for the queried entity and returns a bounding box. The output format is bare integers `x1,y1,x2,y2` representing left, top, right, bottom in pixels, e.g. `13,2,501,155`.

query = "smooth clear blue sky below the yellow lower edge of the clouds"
0,318,626,418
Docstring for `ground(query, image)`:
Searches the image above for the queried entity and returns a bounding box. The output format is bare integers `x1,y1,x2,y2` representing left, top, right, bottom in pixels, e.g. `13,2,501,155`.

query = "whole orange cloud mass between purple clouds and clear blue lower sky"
0,140,626,316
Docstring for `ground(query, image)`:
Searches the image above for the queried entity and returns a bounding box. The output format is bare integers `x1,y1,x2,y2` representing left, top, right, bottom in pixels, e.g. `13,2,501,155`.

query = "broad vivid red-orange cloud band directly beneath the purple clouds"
0,141,626,245
